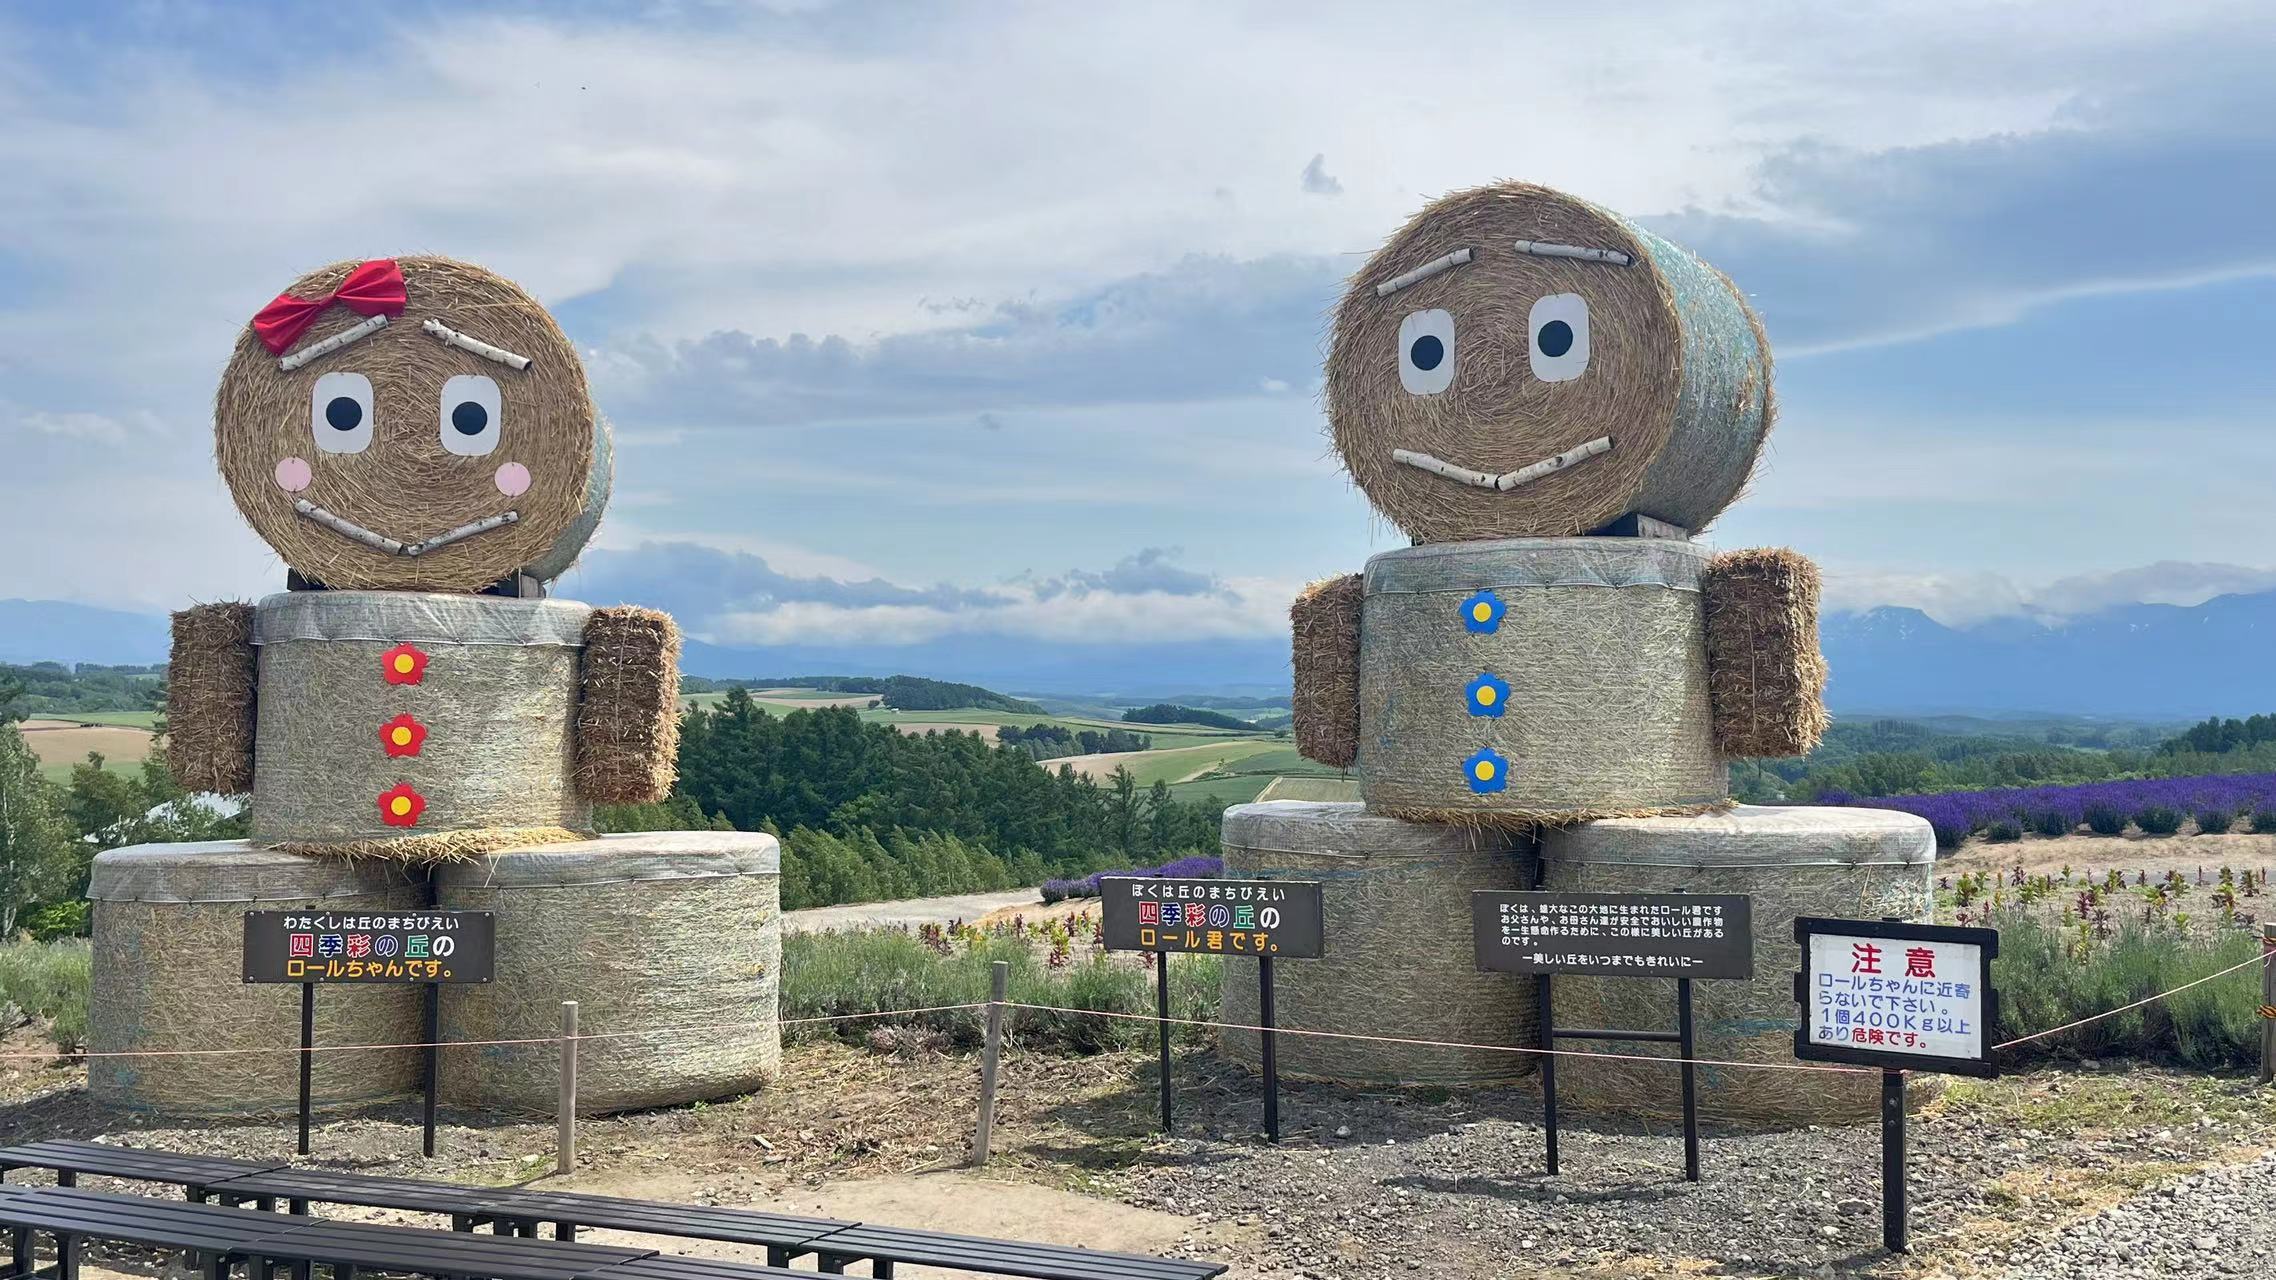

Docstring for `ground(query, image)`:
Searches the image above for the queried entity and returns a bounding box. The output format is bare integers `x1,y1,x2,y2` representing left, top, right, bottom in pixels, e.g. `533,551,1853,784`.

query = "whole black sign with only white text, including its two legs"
1470,888,1755,1182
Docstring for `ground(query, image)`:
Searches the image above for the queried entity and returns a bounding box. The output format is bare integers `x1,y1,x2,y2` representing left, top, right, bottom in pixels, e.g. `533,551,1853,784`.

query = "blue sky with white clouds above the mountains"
0,0,2276,645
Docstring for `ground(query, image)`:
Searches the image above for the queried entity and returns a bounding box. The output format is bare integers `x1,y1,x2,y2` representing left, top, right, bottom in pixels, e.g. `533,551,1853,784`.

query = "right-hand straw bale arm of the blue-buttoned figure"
1700,547,1828,758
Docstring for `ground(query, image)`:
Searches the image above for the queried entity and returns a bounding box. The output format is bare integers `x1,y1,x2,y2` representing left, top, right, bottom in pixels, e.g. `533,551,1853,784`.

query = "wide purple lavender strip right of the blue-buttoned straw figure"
1819,774,2276,850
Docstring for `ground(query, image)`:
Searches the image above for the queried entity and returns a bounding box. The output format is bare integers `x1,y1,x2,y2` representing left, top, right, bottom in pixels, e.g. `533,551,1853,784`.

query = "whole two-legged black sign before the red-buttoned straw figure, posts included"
244,909,498,1157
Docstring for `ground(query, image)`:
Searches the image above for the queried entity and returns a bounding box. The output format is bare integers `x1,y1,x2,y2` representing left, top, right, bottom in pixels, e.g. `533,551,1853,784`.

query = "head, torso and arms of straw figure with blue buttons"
1293,182,1825,827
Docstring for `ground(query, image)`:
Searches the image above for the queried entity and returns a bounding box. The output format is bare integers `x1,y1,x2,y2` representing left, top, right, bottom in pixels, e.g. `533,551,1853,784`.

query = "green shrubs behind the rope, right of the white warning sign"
1992,916,2260,1068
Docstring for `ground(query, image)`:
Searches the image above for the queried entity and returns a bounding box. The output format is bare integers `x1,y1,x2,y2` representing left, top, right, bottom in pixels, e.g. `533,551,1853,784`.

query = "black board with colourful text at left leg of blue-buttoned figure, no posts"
1099,877,1325,959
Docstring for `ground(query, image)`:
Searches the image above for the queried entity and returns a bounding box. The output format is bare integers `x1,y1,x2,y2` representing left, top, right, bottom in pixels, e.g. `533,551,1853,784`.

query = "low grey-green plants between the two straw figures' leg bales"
783,929,1218,1052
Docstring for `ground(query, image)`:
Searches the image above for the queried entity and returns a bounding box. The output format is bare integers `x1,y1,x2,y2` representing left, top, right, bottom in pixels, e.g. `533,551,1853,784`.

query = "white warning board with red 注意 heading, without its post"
1793,918,1998,1075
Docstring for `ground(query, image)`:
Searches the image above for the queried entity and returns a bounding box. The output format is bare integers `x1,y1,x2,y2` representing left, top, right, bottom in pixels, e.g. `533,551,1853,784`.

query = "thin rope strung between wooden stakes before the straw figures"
0,950,2276,1075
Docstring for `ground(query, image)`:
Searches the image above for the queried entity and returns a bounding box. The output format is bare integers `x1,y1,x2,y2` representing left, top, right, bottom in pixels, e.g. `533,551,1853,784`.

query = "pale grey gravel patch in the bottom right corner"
2007,1155,2276,1280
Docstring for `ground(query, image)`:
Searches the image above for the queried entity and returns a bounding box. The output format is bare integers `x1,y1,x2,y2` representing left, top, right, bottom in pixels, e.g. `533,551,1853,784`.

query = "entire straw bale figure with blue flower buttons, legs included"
1224,182,1935,1123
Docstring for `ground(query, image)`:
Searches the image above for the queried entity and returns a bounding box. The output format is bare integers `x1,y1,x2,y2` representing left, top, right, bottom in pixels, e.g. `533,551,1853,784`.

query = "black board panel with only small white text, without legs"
1470,891,1755,977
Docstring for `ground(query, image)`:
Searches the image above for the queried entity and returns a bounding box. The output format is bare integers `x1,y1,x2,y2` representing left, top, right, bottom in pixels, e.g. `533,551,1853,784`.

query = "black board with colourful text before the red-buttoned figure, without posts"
246,911,496,982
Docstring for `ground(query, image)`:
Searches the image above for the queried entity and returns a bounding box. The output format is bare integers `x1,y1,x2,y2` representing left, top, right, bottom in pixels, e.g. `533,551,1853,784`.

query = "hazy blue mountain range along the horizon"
13,592,2276,720
